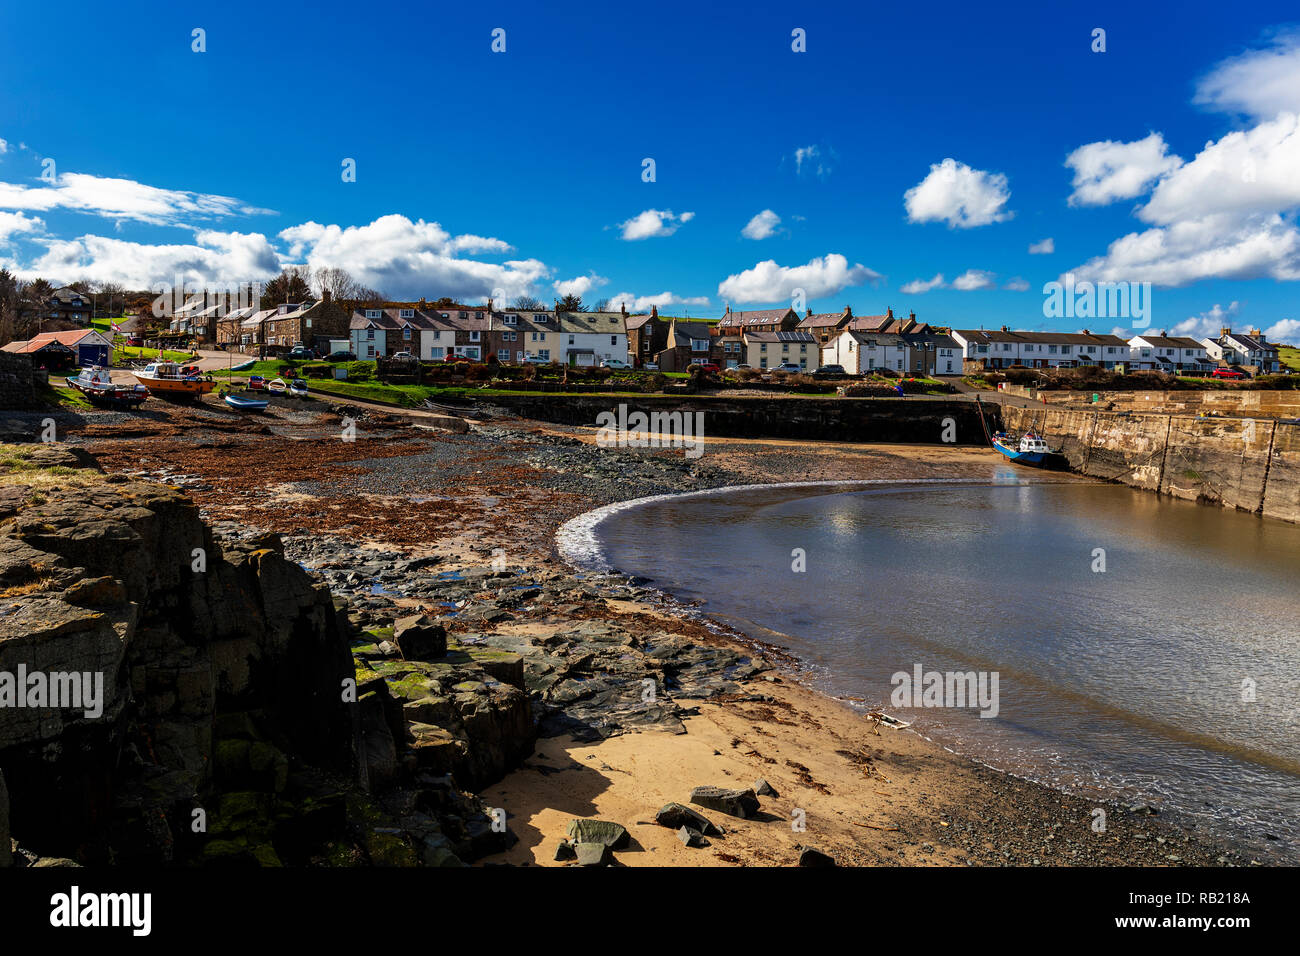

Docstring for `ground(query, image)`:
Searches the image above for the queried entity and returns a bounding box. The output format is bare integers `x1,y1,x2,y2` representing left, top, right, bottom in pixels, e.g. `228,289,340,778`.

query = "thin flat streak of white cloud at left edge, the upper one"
0,173,268,225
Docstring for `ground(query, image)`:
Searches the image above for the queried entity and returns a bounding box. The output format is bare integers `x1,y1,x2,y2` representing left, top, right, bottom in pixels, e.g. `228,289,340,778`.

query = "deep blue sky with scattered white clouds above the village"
0,0,1300,339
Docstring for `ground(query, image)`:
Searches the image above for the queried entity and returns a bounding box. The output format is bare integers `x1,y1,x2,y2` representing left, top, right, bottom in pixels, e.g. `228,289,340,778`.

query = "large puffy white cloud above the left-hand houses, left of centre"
280,215,550,302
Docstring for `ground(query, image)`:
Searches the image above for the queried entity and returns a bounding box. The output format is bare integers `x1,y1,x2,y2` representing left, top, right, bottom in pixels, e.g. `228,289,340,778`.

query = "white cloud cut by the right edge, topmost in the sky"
1192,31,1300,120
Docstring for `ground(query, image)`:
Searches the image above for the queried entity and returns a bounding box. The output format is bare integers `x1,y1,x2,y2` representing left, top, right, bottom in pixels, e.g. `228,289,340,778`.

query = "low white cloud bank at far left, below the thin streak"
12,232,281,289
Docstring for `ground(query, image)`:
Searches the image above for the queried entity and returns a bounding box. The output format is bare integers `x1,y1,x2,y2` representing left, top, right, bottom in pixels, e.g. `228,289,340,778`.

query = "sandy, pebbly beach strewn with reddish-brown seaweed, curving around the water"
2,403,1279,865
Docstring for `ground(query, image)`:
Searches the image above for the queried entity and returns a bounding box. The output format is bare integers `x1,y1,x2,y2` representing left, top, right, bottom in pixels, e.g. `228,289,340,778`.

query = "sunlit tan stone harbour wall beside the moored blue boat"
1002,403,1300,522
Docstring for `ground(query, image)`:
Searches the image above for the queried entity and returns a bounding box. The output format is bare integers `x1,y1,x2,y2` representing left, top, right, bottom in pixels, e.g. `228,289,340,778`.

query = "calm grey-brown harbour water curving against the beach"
590,468,1300,861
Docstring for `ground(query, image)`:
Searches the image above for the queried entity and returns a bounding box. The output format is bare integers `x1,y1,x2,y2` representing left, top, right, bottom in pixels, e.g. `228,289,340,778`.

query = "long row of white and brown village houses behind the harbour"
183,295,1279,376
